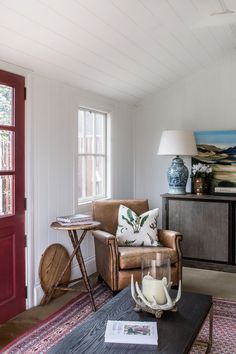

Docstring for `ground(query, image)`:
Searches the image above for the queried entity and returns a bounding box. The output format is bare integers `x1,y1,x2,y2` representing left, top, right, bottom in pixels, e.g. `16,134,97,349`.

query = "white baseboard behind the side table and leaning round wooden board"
33,256,96,306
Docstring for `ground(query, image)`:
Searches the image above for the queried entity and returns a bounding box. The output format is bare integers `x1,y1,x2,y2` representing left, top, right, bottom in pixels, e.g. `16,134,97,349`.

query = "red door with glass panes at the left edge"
0,70,25,323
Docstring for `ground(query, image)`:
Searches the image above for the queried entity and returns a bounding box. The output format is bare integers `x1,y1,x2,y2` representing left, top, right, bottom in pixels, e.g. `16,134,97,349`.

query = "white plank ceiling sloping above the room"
0,0,236,103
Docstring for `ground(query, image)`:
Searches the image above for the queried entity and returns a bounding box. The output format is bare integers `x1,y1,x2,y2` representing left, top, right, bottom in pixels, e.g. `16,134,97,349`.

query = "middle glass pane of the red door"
0,130,14,171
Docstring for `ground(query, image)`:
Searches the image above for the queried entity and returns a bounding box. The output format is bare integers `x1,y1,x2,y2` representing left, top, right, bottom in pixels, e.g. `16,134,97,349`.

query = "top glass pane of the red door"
0,85,13,125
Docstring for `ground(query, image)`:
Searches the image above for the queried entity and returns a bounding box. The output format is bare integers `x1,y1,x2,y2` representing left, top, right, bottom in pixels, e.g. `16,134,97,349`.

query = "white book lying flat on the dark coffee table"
105,320,158,345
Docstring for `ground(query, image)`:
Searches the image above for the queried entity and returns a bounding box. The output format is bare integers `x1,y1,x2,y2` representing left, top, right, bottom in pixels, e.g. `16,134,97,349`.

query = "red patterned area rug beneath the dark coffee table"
0,284,236,354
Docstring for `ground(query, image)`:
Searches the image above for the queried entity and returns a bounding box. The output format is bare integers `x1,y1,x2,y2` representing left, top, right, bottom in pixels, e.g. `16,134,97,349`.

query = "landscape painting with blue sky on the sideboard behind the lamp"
192,130,236,194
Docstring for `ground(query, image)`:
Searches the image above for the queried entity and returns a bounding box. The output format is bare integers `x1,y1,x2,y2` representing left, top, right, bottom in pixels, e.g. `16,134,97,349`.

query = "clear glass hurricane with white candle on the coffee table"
142,253,171,305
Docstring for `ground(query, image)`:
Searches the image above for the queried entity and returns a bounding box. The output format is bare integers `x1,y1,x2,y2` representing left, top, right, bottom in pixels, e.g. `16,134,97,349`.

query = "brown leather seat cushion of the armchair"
118,247,178,270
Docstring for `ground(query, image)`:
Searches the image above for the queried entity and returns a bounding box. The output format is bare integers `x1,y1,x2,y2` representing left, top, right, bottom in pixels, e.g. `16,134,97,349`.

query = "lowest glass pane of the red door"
0,176,13,216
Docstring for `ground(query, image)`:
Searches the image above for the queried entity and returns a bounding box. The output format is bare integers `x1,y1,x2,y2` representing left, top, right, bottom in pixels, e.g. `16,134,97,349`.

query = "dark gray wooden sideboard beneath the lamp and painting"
161,194,236,272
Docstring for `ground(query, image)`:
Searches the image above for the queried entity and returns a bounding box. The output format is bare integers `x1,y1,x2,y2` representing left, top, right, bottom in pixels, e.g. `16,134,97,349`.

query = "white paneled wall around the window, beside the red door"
26,74,133,306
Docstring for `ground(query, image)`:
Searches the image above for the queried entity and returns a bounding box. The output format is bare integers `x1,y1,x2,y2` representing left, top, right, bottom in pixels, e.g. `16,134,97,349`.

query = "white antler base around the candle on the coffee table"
131,274,181,318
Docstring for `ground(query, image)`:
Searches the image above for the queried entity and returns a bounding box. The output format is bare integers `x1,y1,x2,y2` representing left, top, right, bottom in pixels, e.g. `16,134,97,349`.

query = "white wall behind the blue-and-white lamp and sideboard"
134,54,236,222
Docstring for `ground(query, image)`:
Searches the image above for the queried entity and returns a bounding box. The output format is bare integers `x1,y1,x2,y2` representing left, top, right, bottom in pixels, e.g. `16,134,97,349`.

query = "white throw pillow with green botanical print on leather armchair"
116,205,159,246
